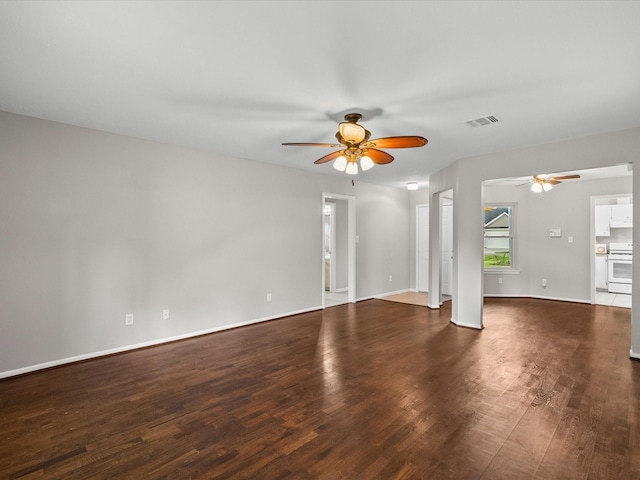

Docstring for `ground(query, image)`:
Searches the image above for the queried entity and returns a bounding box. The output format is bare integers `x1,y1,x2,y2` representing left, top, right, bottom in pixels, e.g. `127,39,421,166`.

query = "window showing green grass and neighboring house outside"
484,205,515,269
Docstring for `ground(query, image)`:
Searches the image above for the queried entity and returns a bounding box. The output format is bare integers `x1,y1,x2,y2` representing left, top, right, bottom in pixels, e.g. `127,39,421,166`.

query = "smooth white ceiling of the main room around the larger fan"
0,1,640,187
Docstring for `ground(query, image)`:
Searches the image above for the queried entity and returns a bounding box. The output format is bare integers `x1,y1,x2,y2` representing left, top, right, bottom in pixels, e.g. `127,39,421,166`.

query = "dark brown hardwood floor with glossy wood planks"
0,299,640,480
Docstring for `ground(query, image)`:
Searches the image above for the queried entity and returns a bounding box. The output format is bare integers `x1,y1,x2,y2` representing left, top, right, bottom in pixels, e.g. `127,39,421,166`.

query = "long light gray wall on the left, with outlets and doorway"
0,112,409,376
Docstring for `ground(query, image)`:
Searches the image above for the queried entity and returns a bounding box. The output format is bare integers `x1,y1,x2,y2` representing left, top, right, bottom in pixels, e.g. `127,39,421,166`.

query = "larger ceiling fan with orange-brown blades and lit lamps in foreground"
282,113,428,175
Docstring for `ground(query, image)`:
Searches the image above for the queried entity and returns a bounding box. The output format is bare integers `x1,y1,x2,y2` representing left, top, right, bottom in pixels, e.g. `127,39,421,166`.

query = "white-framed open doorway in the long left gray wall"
322,194,356,308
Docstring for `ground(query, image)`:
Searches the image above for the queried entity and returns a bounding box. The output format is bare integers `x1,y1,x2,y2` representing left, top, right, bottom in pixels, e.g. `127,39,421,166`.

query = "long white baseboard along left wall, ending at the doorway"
0,305,322,379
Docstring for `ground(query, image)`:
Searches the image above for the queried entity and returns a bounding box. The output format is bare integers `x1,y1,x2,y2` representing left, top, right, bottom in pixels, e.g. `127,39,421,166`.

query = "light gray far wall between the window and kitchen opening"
484,172,633,302
